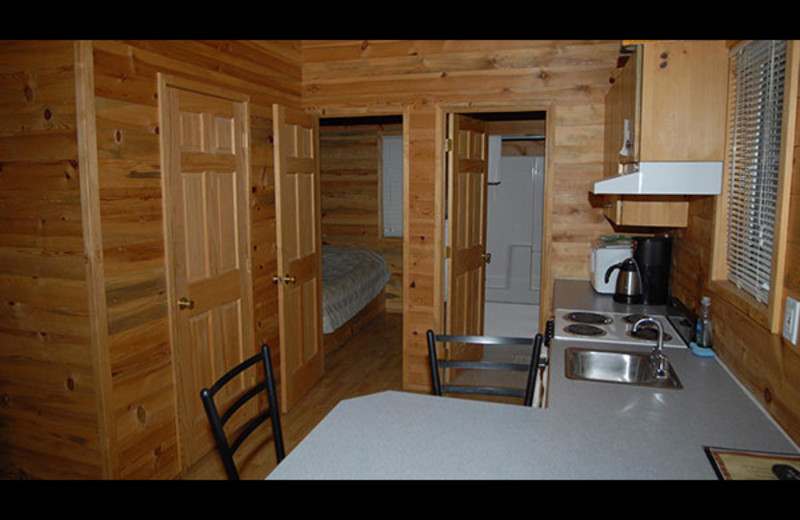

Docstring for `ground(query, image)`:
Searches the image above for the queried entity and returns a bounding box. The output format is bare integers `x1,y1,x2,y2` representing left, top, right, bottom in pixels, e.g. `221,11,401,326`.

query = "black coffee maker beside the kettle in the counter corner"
633,235,672,305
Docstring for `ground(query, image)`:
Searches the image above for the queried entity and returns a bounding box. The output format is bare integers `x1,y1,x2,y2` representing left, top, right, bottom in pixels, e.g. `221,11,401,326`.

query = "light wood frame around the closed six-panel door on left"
156,72,256,471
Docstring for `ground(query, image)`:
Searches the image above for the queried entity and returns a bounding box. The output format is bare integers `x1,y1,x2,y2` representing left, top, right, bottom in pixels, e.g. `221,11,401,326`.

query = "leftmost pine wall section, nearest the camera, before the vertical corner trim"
0,41,103,478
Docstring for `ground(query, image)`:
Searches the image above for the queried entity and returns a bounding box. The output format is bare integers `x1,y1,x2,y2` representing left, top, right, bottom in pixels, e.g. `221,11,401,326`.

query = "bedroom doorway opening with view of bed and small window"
320,114,403,362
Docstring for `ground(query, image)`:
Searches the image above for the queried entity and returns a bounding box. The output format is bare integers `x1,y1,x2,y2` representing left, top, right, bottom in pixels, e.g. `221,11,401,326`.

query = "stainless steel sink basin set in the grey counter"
565,348,683,390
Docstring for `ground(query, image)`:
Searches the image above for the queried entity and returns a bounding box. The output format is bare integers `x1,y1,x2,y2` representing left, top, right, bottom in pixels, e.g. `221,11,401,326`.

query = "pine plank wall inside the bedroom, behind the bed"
320,124,403,313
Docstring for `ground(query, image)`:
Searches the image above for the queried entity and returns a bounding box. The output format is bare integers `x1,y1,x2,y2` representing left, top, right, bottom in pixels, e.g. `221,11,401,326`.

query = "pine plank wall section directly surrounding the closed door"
94,41,300,478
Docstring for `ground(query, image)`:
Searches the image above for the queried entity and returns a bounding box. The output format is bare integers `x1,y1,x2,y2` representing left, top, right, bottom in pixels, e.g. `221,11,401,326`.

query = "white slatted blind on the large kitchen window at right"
727,40,786,302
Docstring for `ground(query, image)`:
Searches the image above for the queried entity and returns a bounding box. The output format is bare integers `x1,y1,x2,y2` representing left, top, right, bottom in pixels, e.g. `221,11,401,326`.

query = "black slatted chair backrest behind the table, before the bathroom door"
427,330,542,406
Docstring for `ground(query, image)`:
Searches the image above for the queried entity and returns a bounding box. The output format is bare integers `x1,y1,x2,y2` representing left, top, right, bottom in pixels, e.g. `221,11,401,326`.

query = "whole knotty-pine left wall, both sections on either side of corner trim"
0,41,301,478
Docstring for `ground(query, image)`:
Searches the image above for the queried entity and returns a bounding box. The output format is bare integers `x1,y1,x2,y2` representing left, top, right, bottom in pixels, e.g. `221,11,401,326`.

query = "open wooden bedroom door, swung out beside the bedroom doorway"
273,105,323,413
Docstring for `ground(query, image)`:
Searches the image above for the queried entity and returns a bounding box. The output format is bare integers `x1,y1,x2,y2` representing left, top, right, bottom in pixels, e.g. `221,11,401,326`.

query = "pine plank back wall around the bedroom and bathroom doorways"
301,40,620,390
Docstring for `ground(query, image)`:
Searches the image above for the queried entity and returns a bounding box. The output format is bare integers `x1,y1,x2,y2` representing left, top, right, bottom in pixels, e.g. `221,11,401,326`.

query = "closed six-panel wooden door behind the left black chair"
159,76,256,467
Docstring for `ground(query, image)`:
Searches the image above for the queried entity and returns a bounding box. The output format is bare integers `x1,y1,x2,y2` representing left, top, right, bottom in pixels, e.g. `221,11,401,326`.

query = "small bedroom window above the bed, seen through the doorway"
381,135,403,237
